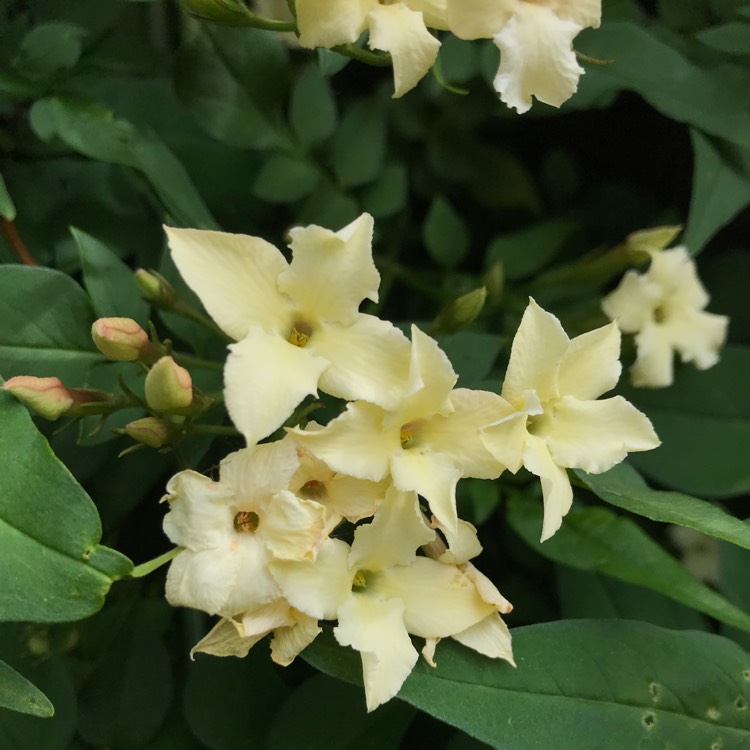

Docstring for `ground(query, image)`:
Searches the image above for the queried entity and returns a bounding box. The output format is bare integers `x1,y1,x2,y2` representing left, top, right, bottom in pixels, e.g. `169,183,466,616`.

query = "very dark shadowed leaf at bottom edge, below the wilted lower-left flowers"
183,643,288,750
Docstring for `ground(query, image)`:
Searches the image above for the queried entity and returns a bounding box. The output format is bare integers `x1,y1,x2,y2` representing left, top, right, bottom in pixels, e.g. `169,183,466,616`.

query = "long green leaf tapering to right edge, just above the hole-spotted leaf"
508,496,750,632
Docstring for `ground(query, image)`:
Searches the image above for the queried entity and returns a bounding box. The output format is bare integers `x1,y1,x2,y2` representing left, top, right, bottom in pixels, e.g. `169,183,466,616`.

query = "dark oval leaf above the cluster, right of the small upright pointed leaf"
331,96,386,188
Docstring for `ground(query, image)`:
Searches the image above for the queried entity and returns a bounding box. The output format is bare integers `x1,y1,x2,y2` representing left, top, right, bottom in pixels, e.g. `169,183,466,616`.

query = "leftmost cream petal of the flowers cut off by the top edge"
295,0,377,49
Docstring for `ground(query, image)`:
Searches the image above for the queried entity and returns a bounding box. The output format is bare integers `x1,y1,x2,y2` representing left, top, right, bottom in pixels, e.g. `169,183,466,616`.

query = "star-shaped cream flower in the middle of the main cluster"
292,326,513,531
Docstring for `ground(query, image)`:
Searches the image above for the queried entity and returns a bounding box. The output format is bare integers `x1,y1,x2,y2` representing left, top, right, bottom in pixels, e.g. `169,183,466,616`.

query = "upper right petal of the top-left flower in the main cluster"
278,214,380,325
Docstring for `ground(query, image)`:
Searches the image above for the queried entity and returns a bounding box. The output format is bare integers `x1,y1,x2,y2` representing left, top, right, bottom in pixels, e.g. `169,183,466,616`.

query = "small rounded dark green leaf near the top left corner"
13,22,86,78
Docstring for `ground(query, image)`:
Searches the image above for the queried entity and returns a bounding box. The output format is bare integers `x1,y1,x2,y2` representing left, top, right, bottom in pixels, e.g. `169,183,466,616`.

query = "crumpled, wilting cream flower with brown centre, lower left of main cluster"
164,439,326,617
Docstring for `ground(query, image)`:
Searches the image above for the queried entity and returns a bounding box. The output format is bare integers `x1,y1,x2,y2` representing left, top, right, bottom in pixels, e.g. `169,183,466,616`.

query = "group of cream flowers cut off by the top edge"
296,0,601,112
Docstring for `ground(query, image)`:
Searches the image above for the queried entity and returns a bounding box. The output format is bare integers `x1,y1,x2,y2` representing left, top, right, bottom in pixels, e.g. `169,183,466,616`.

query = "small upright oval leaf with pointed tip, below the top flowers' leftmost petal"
289,63,338,147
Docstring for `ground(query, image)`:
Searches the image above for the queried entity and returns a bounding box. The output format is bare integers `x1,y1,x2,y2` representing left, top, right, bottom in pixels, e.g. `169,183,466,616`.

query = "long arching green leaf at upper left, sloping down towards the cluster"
30,97,216,229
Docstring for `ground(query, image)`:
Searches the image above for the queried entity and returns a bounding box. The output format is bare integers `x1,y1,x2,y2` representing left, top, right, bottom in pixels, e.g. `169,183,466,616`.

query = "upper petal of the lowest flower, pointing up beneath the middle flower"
349,487,436,571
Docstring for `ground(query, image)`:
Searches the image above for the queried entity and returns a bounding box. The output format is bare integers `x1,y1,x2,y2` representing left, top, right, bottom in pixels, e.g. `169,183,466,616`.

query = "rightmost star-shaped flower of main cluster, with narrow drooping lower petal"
482,300,659,541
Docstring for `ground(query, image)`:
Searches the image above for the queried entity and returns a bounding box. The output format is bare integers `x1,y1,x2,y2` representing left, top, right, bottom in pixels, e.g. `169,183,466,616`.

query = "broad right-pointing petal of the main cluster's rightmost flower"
534,396,659,474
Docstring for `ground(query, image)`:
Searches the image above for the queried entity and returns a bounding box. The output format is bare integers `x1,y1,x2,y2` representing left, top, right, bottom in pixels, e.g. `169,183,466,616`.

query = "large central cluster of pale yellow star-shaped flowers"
164,212,658,710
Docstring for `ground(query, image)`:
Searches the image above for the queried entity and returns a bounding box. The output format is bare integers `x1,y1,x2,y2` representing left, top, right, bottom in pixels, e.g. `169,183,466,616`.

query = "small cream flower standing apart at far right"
602,247,729,388
